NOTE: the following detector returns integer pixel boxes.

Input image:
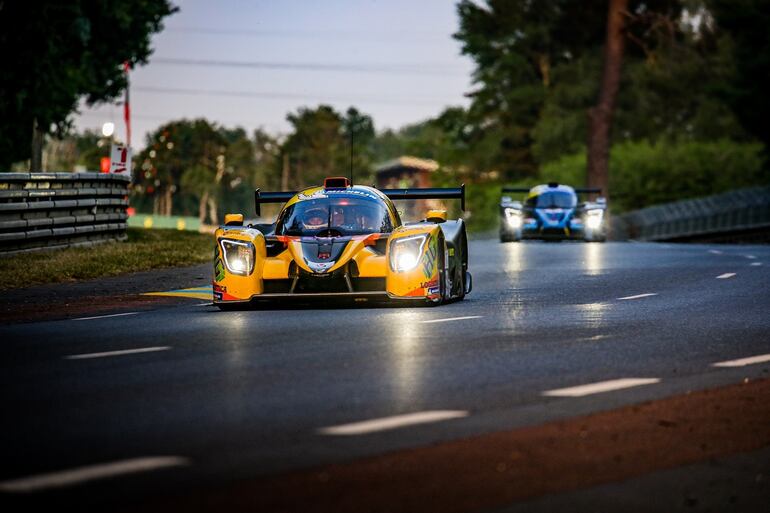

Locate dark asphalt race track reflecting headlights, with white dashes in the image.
[0,240,770,511]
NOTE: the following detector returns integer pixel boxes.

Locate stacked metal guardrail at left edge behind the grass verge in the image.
[0,173,130,255]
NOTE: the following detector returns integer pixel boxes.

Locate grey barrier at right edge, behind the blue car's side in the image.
[612,187,770,242]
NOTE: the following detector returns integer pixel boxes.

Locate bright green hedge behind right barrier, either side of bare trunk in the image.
[540,139,770,212]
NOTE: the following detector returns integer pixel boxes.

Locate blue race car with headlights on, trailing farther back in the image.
[500,182,607,242]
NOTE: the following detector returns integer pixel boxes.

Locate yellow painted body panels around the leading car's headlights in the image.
[213,187,444,303]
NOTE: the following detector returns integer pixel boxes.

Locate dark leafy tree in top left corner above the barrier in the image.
[0,0,177,170]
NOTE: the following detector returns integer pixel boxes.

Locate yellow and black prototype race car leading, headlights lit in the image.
[213,177,472,309]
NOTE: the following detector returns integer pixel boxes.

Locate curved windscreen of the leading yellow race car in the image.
[276,196,393,237]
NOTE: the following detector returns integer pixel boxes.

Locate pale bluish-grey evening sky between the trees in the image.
[75,0,473,149]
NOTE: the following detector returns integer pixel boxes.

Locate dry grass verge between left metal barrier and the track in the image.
[0,228,214,289]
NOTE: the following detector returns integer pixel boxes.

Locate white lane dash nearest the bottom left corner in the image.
[0,456,190,493]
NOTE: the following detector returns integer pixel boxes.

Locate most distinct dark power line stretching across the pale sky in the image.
[151,57,466,76]
